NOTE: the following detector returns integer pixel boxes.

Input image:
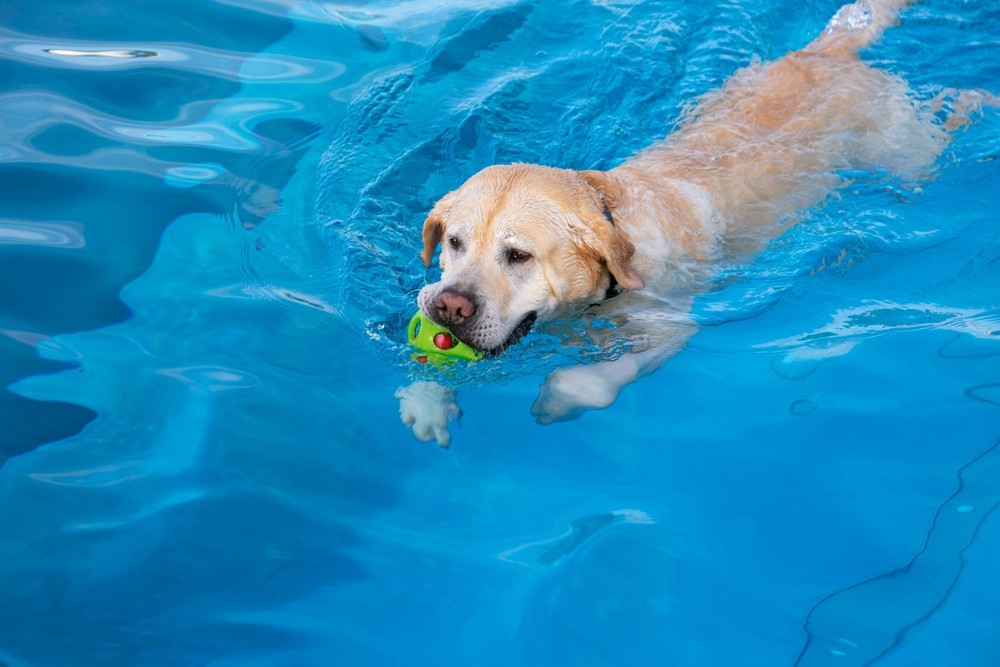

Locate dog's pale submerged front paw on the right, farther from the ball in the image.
[531,364,621,424]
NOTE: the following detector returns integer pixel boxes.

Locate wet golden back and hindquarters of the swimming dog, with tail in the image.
[616,0,947,247]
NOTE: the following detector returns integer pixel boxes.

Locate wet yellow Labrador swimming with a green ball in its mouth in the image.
[396,0,984,446]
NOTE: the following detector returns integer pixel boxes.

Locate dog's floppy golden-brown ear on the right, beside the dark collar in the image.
[578,171,645,289]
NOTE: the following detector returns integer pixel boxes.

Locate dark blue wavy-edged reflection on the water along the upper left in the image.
[0,0,292,461]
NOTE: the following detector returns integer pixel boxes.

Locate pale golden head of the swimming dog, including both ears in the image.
[418,164,643,352]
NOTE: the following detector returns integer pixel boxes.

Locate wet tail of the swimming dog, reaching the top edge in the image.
[803,0,915,58]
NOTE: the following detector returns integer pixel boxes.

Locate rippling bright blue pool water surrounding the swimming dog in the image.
[0,0,1000,667]
